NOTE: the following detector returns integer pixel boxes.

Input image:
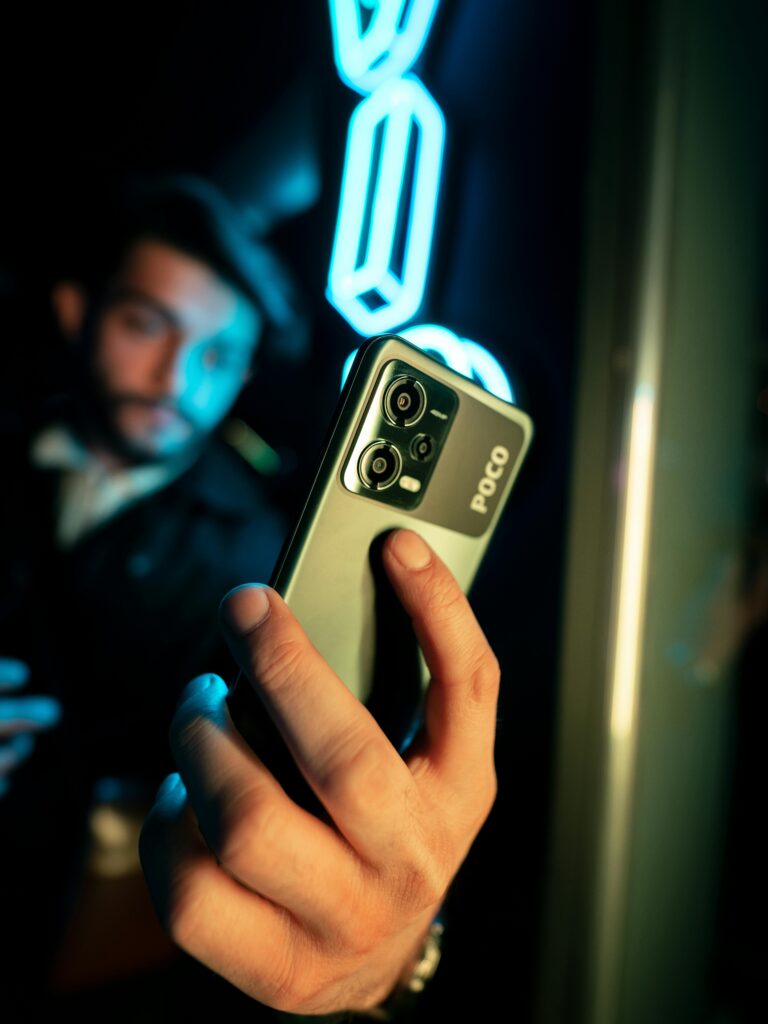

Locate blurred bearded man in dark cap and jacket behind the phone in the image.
[0,179,283,1001]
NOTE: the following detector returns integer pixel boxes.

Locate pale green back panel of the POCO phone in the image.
[272,336,532,700]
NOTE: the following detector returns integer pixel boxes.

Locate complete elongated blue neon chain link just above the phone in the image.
[327,76,445,335]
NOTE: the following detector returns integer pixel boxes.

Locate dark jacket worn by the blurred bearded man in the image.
[0,421,284,1007]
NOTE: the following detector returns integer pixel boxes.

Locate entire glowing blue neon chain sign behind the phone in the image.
[327,0,514,401]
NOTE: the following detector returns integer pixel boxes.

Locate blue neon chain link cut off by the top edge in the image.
[330,0,438,93]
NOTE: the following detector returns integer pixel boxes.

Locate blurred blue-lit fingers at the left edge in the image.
[0,657,61,798]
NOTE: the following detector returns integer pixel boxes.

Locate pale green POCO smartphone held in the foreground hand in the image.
[225,335,532,790]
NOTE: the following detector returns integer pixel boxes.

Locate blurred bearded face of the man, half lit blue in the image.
[92,238,261,460]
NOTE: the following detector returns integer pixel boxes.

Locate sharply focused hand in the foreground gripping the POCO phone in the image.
[140,530,499,1014]
